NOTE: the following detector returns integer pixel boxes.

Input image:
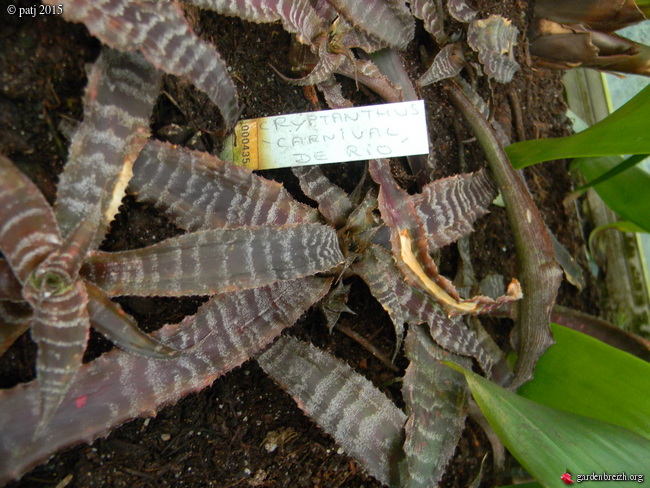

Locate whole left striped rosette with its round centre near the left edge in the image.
[0,43,343,444]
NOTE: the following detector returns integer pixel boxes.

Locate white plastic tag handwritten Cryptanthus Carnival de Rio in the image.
[221,100,429,170]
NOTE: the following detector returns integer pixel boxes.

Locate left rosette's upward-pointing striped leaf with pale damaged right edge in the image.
[56,48,161,243]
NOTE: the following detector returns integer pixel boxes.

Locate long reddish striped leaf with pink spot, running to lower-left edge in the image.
[0,277,331,484]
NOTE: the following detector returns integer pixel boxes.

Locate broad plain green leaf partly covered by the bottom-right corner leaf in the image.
[517,324,650,439]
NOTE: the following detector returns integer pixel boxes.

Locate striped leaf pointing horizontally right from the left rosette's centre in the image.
[83,224,344,296]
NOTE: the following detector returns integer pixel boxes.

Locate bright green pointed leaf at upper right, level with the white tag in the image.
[506,86,650,169]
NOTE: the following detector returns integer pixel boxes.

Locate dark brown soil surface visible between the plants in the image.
[0,0,599,488]
